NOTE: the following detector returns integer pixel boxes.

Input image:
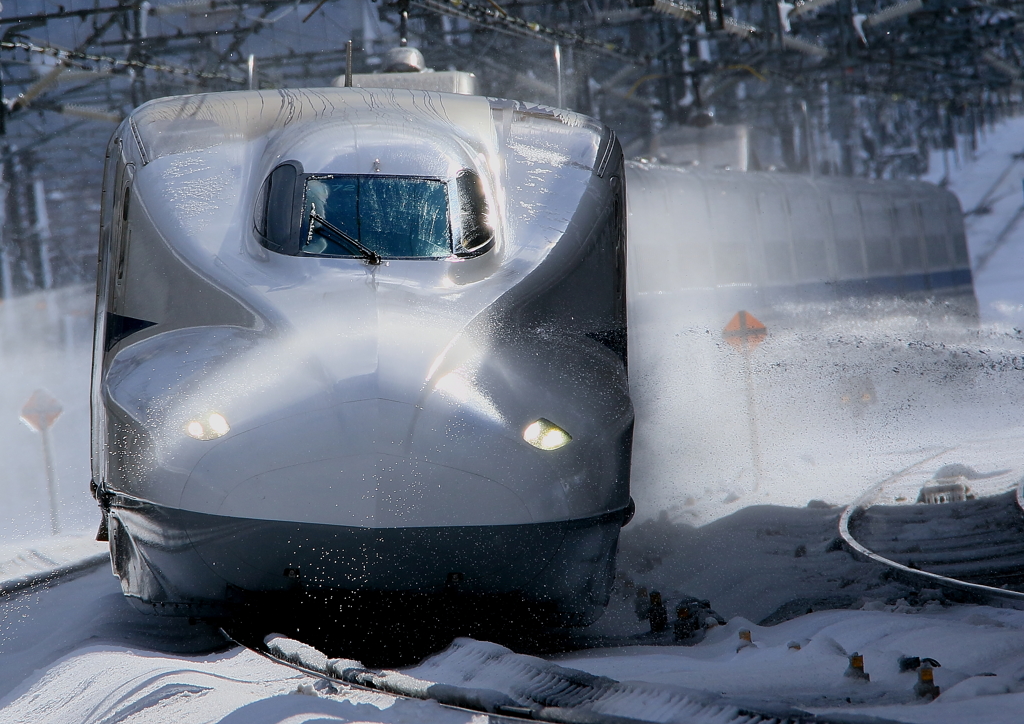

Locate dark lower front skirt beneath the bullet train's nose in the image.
[110,497,625,623]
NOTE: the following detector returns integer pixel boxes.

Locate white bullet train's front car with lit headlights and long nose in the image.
[92,88,633,625]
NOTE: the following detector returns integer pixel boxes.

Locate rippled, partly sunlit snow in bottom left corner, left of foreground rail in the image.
[0,565,458,724]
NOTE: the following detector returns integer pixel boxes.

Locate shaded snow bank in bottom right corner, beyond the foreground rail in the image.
[556,603,1024,724]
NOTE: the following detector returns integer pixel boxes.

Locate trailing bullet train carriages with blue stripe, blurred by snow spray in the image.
[626,162,978,329]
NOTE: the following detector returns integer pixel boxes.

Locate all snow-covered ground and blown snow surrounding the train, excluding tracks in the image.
[6,119,1024,724]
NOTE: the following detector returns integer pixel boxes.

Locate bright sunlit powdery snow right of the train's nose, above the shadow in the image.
[630,301,1024,525]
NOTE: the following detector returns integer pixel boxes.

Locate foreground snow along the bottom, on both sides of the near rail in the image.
[8,565,1024,724]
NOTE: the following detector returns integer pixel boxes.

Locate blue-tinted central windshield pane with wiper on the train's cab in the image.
[299,175,452,261]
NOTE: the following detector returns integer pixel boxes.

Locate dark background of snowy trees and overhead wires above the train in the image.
[0,0,1024,297]
